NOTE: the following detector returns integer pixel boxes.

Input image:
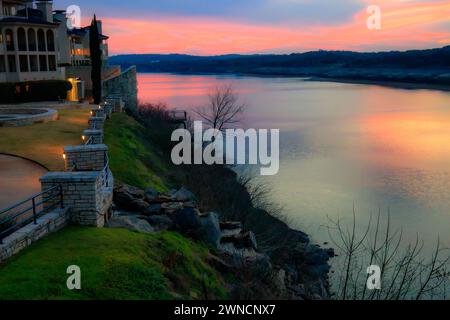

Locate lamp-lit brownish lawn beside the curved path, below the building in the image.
[0,109,90,171]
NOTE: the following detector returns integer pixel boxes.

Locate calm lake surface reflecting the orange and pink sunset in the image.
[139,74,450,250]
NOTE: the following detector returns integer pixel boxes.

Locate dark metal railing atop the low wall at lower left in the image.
[0,185,64,244]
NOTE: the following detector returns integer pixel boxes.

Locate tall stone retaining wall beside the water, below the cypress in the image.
[103,66,138,112]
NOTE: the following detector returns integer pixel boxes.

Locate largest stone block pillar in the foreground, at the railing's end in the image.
[40,171,113,227]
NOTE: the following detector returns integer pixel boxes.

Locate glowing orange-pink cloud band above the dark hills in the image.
[103,1,450,55]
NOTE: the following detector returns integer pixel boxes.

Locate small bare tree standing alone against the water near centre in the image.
[195,85,245,131]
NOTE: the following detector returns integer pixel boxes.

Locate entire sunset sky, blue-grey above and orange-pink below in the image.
[54,0,450,55]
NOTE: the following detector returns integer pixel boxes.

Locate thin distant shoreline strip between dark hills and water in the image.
[138,71,450,92]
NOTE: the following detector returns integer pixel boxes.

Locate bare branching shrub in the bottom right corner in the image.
[328,212,450,300]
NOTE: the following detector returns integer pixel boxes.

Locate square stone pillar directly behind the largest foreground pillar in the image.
[64,144,108,171]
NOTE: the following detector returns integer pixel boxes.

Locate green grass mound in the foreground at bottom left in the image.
[0,227,226,300]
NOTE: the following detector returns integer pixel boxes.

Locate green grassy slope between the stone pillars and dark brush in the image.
[105,113,168,191]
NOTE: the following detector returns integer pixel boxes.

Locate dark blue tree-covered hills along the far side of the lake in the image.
[110,46,450,85]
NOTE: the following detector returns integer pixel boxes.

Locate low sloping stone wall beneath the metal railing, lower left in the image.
[0,207,70,263]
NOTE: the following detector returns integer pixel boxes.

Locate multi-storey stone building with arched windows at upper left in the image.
[0,0,115,99]
